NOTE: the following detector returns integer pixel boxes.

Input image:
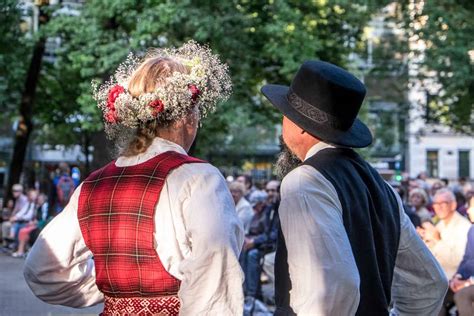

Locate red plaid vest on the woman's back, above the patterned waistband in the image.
[78,151,203,298]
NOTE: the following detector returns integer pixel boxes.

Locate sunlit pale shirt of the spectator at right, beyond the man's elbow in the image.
[428,211,471,279]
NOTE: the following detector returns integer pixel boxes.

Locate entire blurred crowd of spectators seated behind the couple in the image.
[0,164,474,316]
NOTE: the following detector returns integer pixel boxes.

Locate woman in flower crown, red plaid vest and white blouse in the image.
[24,42,243,315]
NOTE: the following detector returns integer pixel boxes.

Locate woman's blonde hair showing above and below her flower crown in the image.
[121,57,189,156]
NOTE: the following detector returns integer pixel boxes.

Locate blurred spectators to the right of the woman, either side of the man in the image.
[229,174,474,316]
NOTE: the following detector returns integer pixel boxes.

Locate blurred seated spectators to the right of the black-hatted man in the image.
[394,174,474,316]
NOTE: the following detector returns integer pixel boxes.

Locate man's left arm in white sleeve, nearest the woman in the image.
[279,166,360,315]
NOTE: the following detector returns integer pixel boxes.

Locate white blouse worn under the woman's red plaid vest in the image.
[24,138,244,316]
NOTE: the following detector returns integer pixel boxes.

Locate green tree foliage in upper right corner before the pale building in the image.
[404,0,474,135]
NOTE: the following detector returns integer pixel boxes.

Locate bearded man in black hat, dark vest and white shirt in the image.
[262,61,447,316]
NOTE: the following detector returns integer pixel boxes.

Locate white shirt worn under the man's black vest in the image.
[279,142,447,316]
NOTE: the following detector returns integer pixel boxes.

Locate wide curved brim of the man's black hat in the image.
[261,84,372,148]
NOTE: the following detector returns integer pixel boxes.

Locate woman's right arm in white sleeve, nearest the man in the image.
[179,169,244,316]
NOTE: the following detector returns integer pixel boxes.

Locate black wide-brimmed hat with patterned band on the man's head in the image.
[261,60,372,148]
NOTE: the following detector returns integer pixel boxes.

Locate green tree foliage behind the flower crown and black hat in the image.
[21,0,386,164]
